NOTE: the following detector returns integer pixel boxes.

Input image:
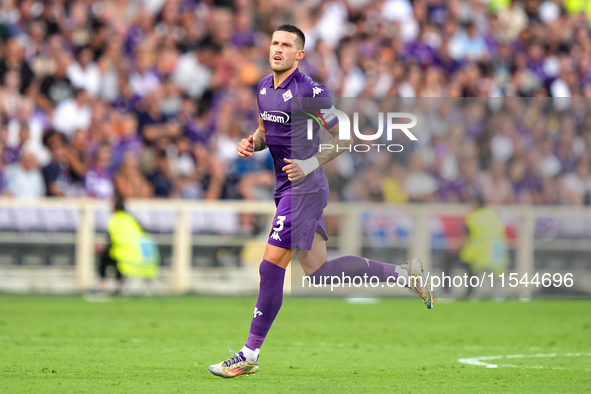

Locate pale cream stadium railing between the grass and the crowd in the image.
[0,198,591,297]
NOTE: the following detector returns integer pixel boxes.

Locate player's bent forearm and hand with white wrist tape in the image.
[283,123,352,182]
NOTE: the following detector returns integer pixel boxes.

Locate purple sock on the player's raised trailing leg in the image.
[310,256,398,282]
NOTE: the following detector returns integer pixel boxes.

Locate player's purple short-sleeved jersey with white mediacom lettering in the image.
[257,68,338,198]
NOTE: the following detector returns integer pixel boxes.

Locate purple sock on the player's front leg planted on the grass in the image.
[246,260,285,350]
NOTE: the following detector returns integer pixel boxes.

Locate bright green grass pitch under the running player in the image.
[0,295,591,393]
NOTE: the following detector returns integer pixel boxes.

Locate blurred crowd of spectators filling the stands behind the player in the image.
[0,0,591,205]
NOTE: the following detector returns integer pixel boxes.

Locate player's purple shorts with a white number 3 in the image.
[269,189,328,250]
